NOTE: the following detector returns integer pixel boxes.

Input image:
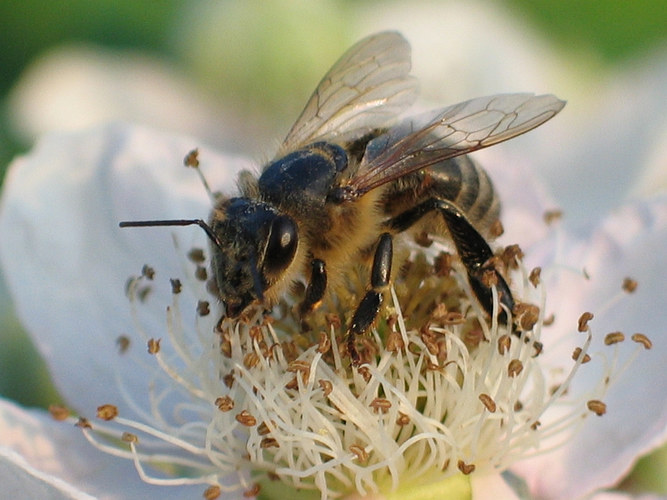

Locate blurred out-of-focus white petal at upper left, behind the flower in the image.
[9,45,235,148]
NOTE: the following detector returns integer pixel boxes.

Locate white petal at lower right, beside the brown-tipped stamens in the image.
[516,196,667,499]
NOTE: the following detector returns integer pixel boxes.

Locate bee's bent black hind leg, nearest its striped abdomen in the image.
[387,198,514,323]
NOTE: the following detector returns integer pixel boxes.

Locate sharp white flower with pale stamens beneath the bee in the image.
[0,111,667,498]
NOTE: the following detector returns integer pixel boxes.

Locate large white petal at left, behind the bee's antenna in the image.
[0,126,253,416]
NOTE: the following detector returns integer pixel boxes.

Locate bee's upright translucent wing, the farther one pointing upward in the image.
[279,31,417,154]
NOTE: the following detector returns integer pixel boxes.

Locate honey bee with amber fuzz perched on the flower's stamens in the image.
[120,32,565,365]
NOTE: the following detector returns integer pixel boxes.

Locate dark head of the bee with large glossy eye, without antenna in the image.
[209,198,298,317]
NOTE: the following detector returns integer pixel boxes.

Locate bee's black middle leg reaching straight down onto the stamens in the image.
[347,233,394,366]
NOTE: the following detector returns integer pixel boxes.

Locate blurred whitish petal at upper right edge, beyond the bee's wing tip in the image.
[528,52,667,228]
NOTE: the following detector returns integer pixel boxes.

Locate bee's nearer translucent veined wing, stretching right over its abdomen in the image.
[346,94,565,197]
